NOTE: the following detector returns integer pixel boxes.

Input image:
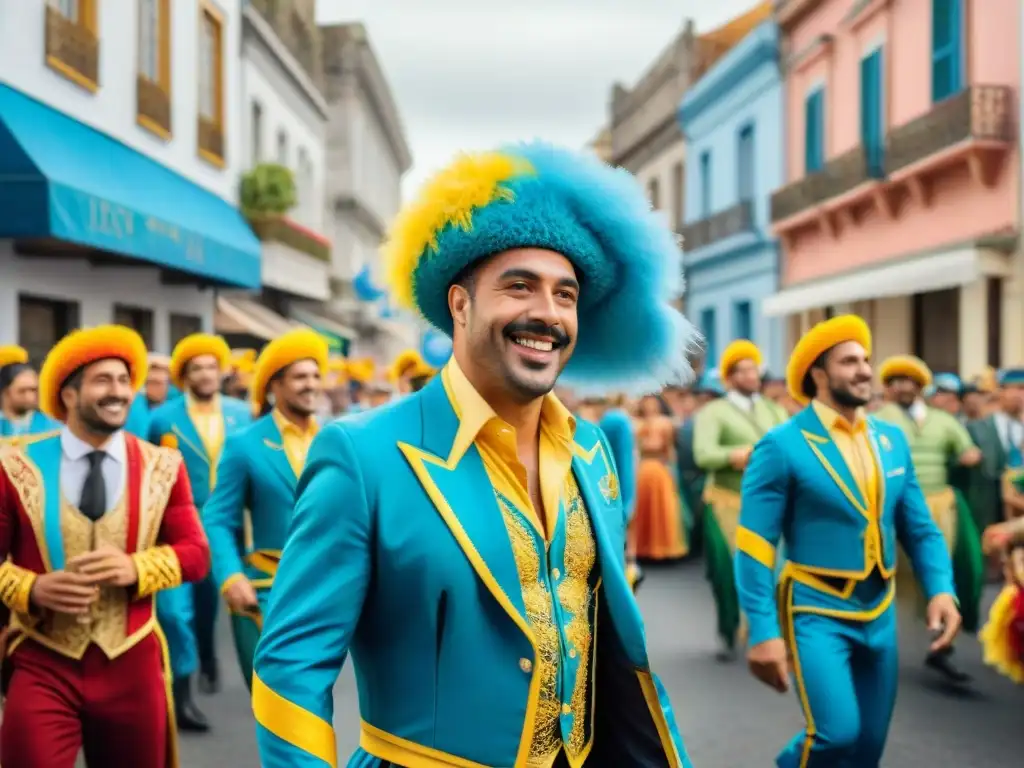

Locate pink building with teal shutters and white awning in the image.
[765,0,1024,376]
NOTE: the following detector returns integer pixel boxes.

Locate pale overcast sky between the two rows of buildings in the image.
[317,0,756,194]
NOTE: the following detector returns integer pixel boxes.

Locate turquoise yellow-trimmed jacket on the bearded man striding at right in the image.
[735,408,955,644]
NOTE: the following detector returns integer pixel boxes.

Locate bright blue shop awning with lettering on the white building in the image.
[0,85,260,289]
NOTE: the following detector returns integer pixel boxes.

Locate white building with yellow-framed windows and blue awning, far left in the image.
[0,0,260,358]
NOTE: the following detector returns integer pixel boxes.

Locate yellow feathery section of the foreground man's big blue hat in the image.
[381,153,534,309]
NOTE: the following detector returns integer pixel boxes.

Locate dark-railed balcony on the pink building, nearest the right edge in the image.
[885,85,1016,198]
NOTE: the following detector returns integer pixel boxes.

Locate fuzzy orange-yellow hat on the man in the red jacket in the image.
[39,326,150,421]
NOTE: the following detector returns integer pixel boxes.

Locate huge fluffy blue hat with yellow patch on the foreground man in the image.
[383,142,698,394]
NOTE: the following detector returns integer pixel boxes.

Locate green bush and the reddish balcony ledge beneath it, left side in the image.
[239,163,331,261]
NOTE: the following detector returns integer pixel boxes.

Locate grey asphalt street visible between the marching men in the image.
[181,563,1024,768]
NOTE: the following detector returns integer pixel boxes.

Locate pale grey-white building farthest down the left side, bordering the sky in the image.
[321,24,420,361]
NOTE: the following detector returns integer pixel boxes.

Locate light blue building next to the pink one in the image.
[679,20,785,374]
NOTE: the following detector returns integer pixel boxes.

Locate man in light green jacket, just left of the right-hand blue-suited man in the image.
[693,339,786,662]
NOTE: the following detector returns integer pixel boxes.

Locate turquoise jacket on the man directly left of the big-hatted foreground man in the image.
[203,414,298,609]
